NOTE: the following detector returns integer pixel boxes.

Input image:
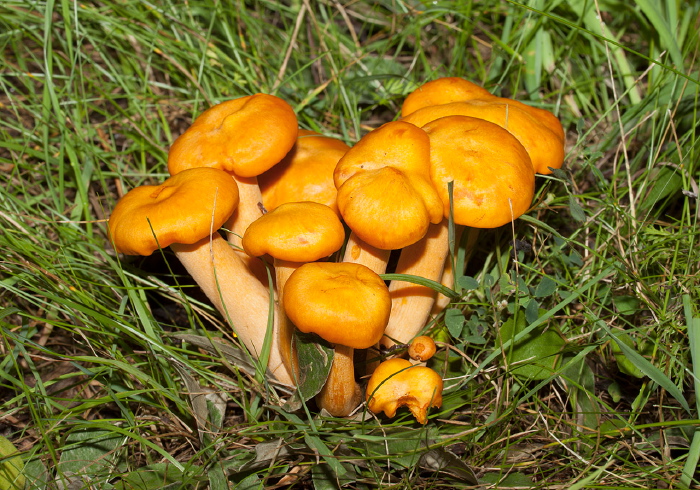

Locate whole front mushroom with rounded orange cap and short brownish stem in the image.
[284,262,391,417]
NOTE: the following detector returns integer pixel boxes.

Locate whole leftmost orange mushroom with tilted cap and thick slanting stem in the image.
[109,168,291,384]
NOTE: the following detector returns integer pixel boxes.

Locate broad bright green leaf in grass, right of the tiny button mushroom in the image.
[500,310,566,380]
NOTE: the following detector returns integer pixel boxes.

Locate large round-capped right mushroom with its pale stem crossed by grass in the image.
[381,116,535,347]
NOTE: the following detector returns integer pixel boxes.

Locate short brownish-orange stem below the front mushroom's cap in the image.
[316,344,362,417]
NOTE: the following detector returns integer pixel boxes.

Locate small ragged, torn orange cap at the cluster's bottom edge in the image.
[367,357,443,424]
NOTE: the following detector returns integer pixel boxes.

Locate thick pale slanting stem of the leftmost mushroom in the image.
[170,233,294,385]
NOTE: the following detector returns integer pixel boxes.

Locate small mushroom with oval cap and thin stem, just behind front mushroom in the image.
[242,201,345,376]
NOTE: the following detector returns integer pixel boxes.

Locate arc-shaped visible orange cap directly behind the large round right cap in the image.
[403,96,564,174]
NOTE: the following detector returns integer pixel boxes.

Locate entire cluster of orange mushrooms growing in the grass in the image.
[109,77,564,423]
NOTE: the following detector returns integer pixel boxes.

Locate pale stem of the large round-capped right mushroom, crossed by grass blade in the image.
[381,220,449,347]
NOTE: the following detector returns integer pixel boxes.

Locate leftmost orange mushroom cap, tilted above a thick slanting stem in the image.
[109,168,238,255]
